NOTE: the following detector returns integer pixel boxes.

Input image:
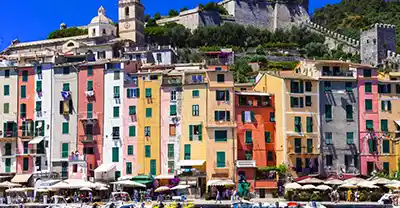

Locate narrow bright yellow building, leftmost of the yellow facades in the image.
[136,72,162,175]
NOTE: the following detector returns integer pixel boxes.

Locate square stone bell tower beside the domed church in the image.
[118,0,144,45]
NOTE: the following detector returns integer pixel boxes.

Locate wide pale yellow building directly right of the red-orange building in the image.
[254,72,320,176]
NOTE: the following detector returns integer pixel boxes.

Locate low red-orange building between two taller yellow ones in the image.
[235,91,277,197]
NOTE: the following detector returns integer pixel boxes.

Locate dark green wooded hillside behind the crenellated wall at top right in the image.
[312,0,400,49]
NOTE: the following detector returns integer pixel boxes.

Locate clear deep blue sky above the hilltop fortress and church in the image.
[0,0,340,50]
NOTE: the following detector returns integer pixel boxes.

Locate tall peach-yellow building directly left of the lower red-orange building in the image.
[206,70,237,183]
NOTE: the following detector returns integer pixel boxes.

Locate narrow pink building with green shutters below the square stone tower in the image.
[357,67,381,175]
